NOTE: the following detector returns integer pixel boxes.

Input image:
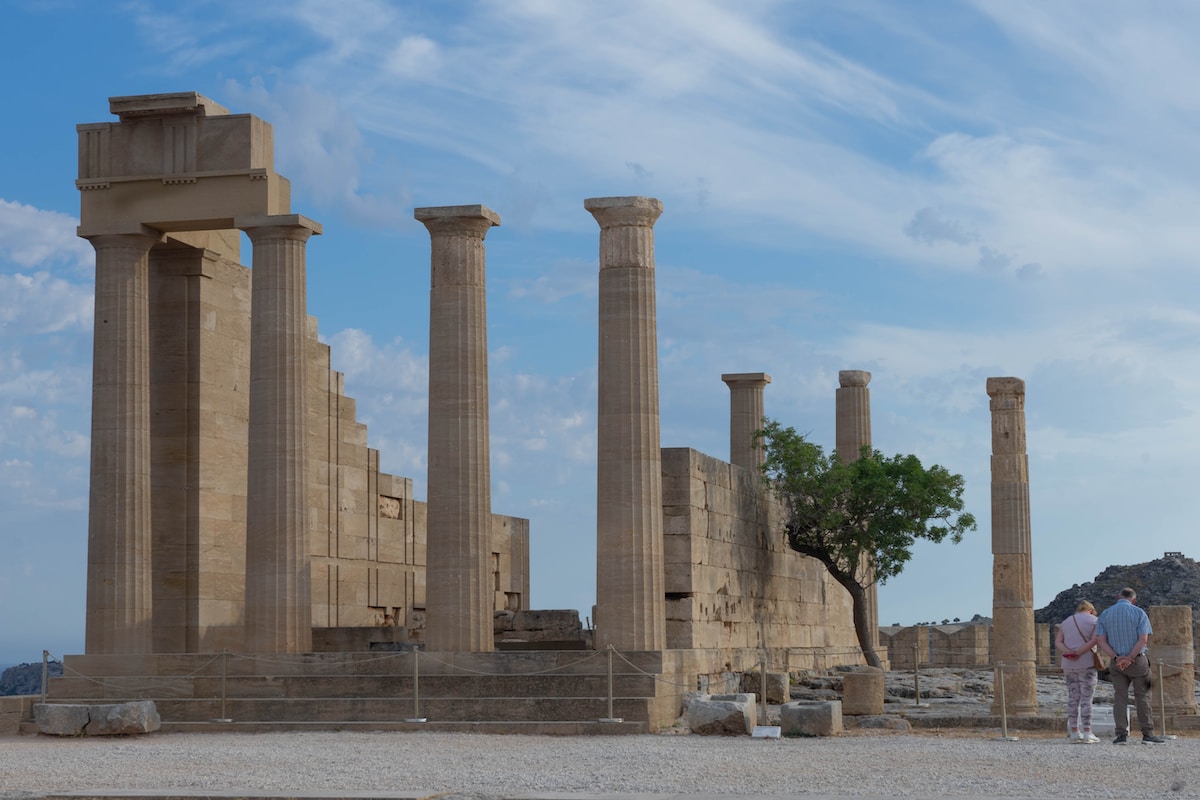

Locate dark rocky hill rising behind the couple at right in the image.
[1033,553,1200,624]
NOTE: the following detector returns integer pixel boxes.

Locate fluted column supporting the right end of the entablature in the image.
[236,215,320,652]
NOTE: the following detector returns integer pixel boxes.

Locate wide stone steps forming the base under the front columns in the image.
[23,650,682,734]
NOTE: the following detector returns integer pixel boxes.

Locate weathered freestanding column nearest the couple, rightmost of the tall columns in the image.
[988,378,1038,716]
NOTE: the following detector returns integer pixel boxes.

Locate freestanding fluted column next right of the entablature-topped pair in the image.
[414,205,500,652]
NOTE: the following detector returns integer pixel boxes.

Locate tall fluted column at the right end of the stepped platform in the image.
[583,197,666,650]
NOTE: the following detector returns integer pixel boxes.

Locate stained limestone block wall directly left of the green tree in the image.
[662,447,863,669]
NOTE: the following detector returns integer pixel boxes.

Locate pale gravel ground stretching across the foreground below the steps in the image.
[0,732,1200,800]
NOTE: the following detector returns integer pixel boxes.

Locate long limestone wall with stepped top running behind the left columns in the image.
[149,235,529,652]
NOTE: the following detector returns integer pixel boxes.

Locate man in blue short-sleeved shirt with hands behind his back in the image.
[1096,587,1166,745]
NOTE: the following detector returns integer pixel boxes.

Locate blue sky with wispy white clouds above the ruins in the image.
[0,0,1200,663]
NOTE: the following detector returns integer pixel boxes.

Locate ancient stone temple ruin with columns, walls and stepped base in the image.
[46,92,870,729]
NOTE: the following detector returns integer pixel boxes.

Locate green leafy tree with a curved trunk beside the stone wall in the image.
[756,420,976,667]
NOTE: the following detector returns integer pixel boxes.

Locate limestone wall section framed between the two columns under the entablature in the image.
[150,240,250,652]
